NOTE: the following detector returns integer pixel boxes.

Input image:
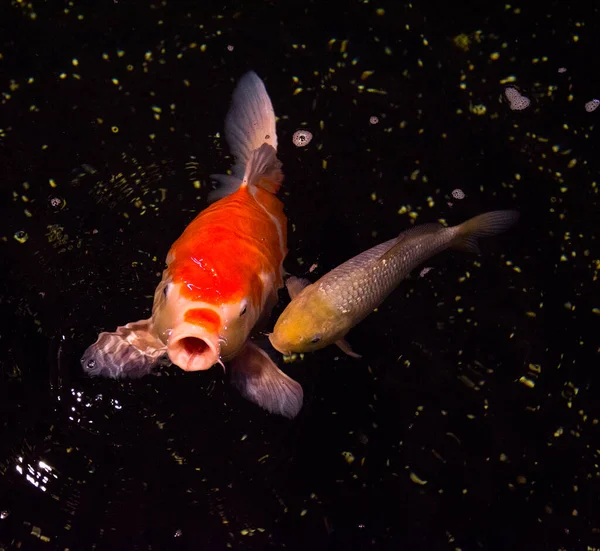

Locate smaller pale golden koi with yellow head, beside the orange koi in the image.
[269,211,519,357]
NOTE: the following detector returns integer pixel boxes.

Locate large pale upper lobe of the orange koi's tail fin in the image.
[209,71,277,200]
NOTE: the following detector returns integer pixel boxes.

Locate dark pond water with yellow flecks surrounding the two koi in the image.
[0,0,600,550]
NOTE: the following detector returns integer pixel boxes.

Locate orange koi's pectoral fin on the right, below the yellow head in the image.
[229,341,304,419]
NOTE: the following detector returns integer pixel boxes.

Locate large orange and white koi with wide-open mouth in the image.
[81,72,303,418]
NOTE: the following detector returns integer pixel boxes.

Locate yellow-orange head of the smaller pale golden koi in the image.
[269,289,343,354]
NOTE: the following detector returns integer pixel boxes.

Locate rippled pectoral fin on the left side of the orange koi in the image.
[81,318,166,379]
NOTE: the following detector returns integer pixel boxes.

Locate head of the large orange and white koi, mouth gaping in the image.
[152,269,261,371]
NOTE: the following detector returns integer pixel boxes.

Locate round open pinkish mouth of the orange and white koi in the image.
[167,324,220,371]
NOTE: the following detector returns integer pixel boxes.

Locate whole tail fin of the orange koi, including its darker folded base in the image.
[209,71,283,201]
